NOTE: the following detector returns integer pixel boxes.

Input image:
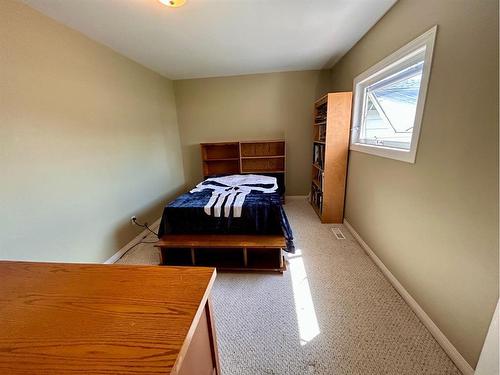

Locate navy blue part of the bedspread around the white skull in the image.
[158,190,295,253]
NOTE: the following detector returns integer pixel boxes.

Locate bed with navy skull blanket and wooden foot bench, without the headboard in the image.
[158,174,294,271]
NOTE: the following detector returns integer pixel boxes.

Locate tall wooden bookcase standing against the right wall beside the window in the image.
[310,92,352,223]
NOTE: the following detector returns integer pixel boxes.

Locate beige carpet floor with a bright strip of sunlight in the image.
[120,198,460,375]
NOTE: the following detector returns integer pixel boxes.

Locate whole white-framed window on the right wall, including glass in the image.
[350,26,437,163]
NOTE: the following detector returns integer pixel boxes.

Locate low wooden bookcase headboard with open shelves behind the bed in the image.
[201,140,286,178]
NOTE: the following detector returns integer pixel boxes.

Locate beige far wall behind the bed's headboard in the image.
[174,71,328,195]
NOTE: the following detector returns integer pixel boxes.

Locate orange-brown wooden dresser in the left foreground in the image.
[0,262,220,375]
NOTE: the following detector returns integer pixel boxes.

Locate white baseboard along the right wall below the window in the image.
[344,220,474,375]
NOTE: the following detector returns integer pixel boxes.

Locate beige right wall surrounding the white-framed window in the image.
[333,0,498,366]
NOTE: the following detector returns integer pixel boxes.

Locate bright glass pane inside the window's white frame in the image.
[359,59,424,150]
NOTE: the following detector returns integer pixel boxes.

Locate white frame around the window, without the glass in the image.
[350,25,437,163]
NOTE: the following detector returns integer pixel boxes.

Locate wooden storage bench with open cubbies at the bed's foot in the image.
[155,234,286,272]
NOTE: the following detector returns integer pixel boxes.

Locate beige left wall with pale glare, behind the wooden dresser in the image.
[0,0,184,262]
